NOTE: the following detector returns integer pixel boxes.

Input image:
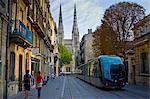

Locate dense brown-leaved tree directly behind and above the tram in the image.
[94,21,118,56]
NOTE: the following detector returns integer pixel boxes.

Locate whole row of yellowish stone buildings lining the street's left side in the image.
[0,0,59,99]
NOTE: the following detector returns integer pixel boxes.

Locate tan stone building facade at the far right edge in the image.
[133,15,150,85]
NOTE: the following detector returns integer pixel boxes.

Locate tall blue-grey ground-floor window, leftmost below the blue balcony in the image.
[9,52,15,81]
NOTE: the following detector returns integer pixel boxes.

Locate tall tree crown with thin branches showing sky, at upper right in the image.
[103,2,145,52]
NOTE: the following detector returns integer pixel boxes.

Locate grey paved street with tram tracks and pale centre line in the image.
[9,76,150,99]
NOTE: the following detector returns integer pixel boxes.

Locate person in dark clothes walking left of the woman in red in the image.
[23,70,31,99]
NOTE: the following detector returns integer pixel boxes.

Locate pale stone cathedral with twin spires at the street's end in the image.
[58,5,79,72]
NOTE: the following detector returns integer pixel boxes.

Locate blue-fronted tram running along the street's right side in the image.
[76,55,127,88]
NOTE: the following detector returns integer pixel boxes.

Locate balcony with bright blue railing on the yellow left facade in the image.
[11,20,32,44]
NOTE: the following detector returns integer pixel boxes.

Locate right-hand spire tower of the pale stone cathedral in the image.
[72,5,79,57]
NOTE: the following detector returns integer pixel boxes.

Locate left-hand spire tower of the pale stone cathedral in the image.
[58,4,64,44]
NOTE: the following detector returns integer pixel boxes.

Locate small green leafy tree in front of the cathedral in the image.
[58,45,72,67]
